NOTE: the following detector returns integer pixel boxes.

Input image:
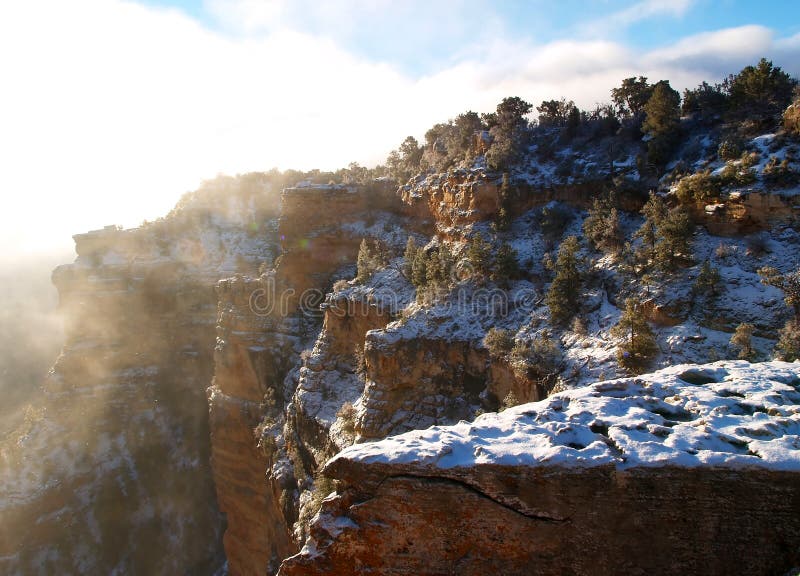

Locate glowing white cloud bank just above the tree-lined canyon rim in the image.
[0,0,800,260]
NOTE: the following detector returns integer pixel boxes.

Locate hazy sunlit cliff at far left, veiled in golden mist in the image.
[0,183,275,574]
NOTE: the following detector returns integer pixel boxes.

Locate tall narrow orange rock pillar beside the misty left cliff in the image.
[208,277,297,574]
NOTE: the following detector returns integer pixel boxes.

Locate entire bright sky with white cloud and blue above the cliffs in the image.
[0,0,800,263]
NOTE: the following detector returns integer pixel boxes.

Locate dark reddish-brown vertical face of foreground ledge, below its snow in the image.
[279,460,800,576]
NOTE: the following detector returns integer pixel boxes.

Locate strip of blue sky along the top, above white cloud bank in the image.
[134,0,800,75]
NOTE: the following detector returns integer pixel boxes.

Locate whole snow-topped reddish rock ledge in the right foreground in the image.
[279,362,800,576]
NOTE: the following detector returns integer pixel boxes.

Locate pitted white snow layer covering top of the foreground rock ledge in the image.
[328,361,800,471]
